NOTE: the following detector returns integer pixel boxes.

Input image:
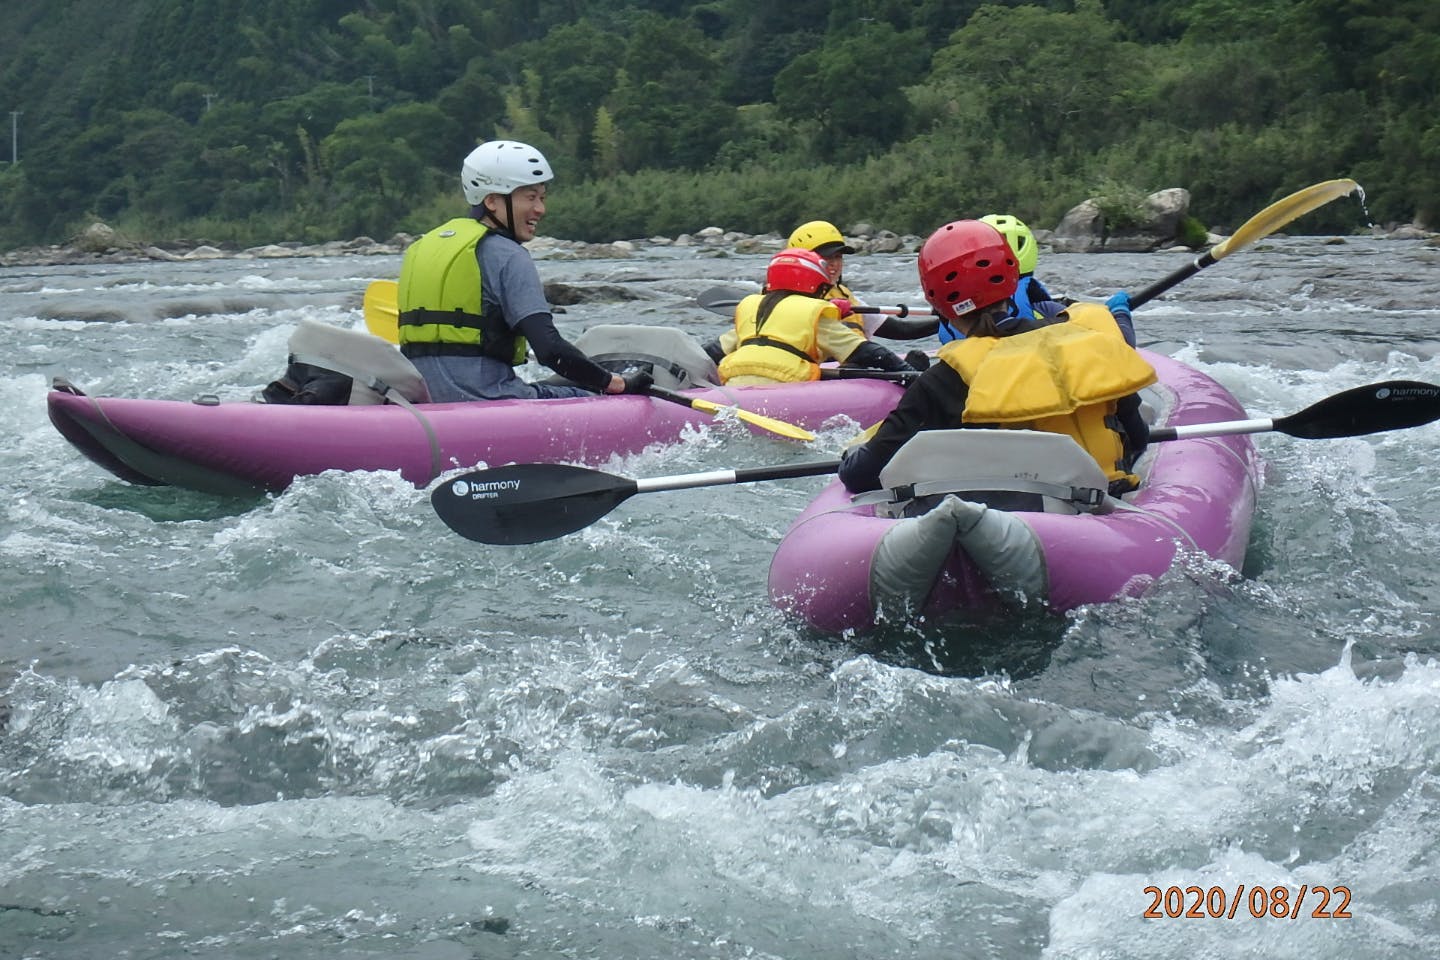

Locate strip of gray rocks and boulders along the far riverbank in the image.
[0,187,1440,266]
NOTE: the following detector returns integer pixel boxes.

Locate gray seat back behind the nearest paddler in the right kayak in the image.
[855,429,1113,517]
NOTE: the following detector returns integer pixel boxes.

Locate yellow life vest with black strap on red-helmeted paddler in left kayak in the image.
[720,291,840,383]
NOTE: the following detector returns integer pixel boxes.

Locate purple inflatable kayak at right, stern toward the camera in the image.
[769,353,1260,632]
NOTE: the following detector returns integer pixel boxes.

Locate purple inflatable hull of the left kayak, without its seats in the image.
[48,379,903,495]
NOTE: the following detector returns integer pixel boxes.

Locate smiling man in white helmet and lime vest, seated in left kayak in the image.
[399,140,651,403]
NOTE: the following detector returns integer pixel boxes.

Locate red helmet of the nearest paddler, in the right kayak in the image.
[919,220,1020,320]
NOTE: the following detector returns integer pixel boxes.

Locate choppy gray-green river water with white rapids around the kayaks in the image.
[0,237,1440,960]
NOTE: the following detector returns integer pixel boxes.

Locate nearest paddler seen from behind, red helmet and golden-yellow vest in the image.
[840,220,1156,495]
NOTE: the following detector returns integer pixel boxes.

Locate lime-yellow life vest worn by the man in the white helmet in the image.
[396,217,526,366]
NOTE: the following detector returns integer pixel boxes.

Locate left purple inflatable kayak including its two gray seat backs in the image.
[49,320,904,497]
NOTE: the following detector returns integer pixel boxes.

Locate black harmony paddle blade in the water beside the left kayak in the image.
[431,463,636,544]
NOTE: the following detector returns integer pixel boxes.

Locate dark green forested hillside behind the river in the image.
[0,0,1440,248]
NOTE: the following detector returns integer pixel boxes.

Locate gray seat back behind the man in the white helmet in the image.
[289,320,431,406]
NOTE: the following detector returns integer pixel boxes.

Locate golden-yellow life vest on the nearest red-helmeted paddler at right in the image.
[939,304,1156,485]
